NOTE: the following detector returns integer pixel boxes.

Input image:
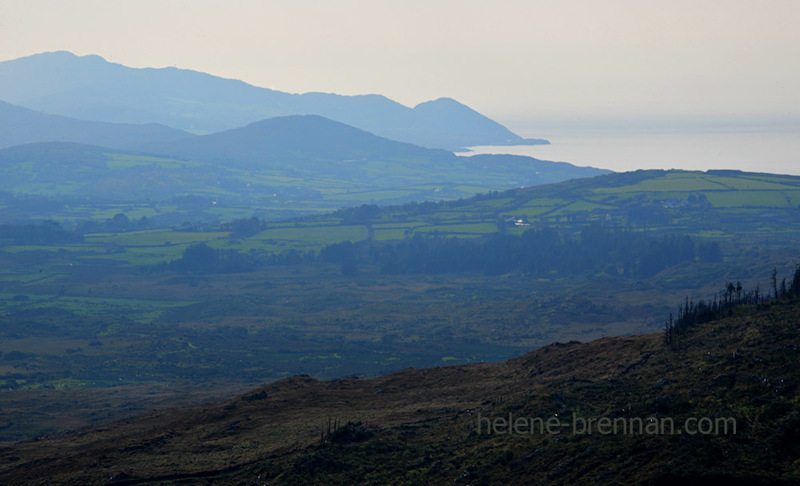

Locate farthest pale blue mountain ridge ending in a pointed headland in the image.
[0,52,547,150]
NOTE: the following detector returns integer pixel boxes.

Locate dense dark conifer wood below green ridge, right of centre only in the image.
[319,225,722,278]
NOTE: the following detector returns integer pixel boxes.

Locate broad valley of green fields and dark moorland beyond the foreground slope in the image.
[0,171,800,439]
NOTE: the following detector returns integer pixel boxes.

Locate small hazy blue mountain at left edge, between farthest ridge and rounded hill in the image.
[0,101,192,149]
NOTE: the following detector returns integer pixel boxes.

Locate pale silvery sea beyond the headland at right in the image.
[461,122,800,175]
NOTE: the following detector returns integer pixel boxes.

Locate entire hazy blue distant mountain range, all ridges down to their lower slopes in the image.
[0,52,608,221]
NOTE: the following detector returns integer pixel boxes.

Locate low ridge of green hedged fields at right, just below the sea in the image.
[358,167,800,241]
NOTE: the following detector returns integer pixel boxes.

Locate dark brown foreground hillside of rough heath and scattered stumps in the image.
[0,292,800,485]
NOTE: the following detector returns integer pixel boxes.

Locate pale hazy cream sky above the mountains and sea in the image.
[0,0,800,123]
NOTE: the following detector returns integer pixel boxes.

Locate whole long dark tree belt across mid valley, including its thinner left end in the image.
[151,219,722,278]
